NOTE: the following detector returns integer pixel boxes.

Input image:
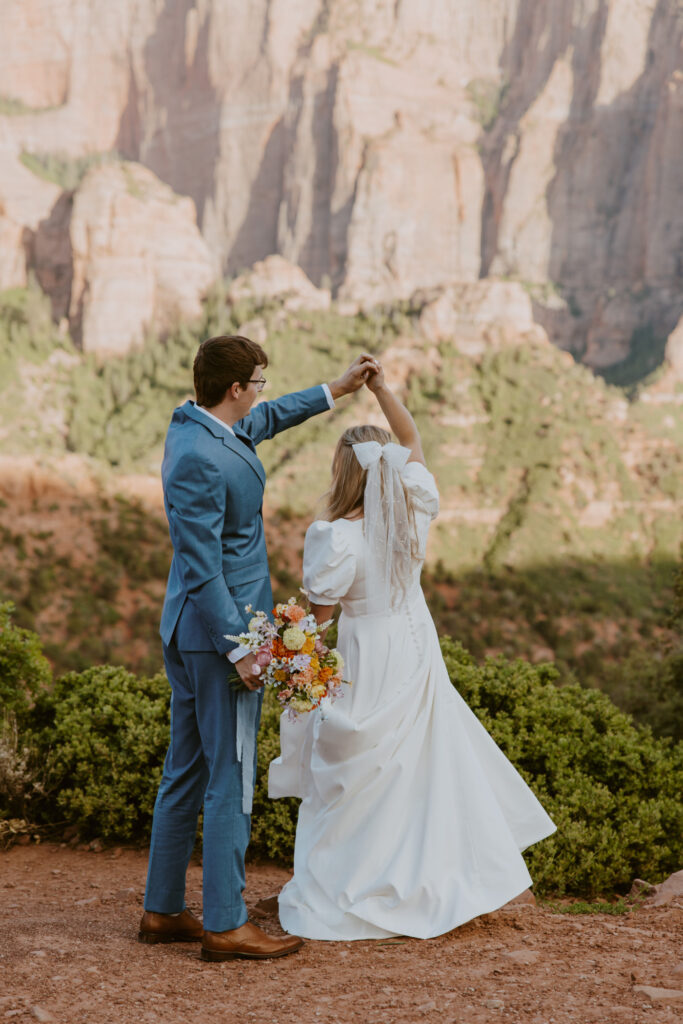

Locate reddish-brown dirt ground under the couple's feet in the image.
[0,844,683,1024]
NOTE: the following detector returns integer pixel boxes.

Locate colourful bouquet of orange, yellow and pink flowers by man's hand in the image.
[226,597,348,717]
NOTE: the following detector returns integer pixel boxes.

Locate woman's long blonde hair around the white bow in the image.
[323,424,419,557]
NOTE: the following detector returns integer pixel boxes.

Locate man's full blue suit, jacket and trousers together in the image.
[144,387,330,932]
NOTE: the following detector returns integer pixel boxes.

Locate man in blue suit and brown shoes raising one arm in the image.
[138,336,377,961]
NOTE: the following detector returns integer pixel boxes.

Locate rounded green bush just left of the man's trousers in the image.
[32,666,169,840]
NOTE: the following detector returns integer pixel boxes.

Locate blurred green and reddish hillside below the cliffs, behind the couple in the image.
[0,276,683,731]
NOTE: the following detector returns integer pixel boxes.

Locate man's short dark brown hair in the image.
[193,334,268,409]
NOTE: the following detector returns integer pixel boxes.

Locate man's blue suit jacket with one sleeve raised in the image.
[160,386,330,654]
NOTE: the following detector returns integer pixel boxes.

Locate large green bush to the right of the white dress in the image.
[441,639,683,895]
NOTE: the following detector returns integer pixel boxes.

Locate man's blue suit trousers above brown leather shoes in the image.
[144,643,262,932]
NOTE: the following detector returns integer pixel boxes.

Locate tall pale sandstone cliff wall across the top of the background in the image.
[0,0,683,367]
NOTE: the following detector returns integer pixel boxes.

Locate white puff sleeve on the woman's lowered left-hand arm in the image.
[303,519,355,604]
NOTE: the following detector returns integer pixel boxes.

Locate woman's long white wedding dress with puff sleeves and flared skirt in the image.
[269,462,555,940]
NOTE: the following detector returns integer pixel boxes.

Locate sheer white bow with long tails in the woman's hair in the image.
[352,441,413,613]
